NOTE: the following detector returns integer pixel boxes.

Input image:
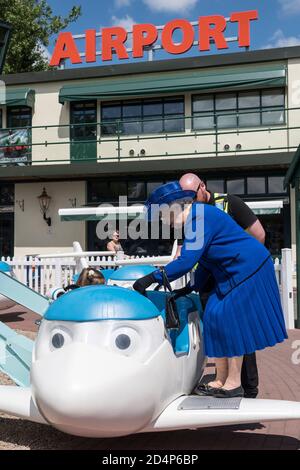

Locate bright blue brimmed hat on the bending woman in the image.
[145,181,196,220]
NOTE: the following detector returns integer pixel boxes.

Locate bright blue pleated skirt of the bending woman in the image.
[203,258,287,357]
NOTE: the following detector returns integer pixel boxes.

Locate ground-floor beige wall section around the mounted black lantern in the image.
[15,181,86,256]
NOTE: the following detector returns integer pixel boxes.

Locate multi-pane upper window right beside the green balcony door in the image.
[101,97,185,135]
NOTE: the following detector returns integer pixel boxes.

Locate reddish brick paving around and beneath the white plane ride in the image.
[0,308,300,451]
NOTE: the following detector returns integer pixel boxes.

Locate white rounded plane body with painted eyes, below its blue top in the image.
[31,312,204,437]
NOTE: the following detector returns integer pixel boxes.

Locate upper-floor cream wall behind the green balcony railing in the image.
[4,59,300,164]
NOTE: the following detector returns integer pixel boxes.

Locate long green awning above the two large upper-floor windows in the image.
[59,64,286,104]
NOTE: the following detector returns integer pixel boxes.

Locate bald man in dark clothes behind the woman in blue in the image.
[179,173,265,398]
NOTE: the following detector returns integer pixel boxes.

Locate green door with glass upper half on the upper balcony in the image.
[71,101,97,162]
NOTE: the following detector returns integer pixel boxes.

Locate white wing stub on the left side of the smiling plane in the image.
[0,385,48,424]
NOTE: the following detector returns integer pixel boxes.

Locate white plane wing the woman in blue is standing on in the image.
[141,395,300,432]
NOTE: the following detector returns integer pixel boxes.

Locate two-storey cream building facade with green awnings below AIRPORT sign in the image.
[0,47,300,256]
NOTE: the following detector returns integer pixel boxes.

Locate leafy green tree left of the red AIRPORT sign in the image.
[0,0,81,73]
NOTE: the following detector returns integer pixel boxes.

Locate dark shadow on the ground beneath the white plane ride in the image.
[0,418,300,451]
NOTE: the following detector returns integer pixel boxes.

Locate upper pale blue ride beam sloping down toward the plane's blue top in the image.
[0,272,49,316]
